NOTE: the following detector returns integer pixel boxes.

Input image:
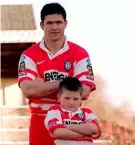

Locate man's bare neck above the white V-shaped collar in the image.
[44,37,65,54]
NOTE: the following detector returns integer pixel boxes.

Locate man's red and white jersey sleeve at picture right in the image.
[74,48,96,91]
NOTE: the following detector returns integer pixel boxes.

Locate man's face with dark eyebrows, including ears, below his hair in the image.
[40,14,67,41]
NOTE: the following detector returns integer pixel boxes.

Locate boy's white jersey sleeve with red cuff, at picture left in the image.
[44,107,65,133]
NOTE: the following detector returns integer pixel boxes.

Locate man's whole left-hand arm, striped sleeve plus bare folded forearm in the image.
[18,52,59,99]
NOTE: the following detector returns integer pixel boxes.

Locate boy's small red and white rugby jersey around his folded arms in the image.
[44,105,101,145]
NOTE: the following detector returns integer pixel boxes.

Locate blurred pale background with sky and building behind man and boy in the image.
[0,0,135,145]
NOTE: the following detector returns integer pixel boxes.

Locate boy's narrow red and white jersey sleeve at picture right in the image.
[85,109,101,139]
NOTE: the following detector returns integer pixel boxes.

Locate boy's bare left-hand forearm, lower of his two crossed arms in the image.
[51,128,84,139]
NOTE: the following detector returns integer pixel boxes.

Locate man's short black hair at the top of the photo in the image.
[40,3,66,22]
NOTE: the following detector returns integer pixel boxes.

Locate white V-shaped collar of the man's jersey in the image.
[40,36,69,59]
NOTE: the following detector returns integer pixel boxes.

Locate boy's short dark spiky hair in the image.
[59,77,82,95]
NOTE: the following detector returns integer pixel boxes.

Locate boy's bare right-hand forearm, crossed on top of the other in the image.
[66,123,98,136]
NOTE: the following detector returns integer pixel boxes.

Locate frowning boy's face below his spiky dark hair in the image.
[58,89,82,111]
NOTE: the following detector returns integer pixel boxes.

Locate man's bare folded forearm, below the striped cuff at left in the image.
[20,80,59,99]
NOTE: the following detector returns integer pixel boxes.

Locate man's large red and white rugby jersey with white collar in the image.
[18,37,95,113]
